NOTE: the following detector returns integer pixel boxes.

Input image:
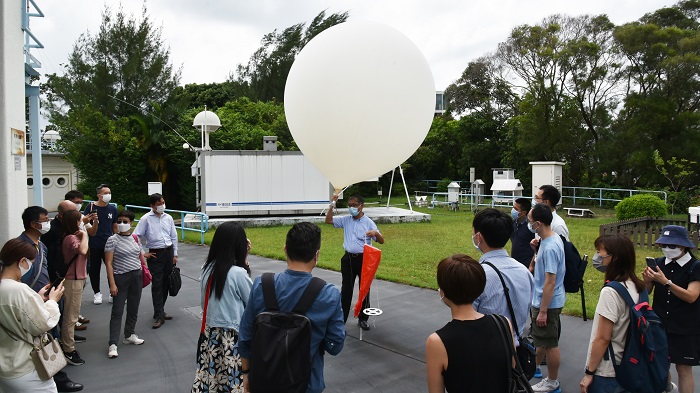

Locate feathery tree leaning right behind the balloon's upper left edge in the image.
[229,11,350,102]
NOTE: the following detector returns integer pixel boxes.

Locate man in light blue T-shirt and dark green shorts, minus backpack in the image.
[527,204,566,393]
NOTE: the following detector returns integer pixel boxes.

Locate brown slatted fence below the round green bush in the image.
[600,217,700,248]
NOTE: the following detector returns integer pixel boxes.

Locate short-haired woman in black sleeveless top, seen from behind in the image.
[425,254,515,393]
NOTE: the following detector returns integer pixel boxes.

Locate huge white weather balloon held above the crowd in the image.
[284,22,435,189]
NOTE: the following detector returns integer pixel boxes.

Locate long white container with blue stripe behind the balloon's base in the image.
[200,150,333,217]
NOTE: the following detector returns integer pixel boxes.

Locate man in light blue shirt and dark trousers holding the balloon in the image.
[325,194,384,330]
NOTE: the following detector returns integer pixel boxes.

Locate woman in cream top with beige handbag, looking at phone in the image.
[0,239,63,392]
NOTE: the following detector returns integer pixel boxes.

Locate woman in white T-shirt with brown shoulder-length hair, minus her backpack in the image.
[580,235,646,393]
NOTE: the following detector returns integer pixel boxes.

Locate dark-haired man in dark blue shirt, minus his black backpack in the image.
[238,222,345,393]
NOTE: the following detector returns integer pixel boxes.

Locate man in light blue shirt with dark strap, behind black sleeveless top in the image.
[472,209,534,345]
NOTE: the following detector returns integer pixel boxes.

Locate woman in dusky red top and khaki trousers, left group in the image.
[61,210,89,366]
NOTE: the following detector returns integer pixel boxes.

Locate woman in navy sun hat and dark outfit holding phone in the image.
[642,225,700,393]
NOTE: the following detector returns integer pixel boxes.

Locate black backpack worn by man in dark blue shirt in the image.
[248,273,326,393]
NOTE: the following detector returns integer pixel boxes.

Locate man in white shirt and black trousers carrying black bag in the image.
[133,194,177,329]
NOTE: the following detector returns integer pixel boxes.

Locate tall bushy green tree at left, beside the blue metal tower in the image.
[43,5,179,203]
